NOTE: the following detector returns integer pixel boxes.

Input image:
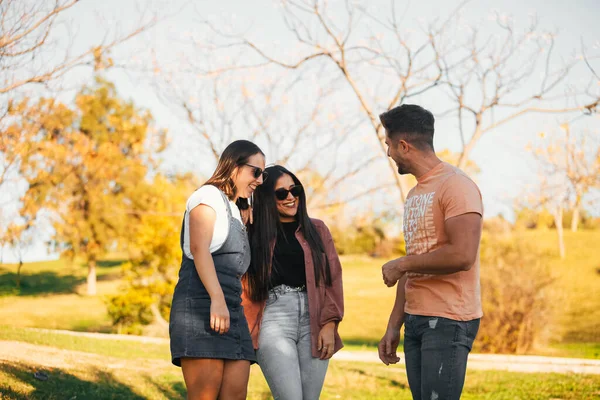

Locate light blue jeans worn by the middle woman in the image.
[256,285,329,400]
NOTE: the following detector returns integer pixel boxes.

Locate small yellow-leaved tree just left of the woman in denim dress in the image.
[108,173,198,334]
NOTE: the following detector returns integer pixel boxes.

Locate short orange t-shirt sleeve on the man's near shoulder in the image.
[440,174,483,221]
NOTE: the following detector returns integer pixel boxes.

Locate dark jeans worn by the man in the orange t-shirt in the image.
[404,314,480,400]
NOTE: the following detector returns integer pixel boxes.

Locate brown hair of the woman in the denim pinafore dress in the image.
[204,140,265,200]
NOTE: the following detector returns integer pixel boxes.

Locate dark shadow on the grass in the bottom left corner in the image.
[0,363,144,400]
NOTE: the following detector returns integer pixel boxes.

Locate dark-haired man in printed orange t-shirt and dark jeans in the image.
[379,104,483,400]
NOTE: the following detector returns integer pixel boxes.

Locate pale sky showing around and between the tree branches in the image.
[3,0,600,261]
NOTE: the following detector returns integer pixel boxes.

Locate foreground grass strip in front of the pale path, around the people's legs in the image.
[0,326,600,400]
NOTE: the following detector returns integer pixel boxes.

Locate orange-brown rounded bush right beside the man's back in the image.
[475,234,558,354]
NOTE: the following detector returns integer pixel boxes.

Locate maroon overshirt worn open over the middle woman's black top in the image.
[242,218,344,357]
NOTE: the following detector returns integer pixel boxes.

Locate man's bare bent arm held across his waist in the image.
[383,212,481,286]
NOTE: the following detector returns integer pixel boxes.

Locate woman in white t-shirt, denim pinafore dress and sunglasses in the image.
[169,140,267,399]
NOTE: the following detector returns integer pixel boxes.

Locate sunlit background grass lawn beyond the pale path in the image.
[0,231,600,358]
